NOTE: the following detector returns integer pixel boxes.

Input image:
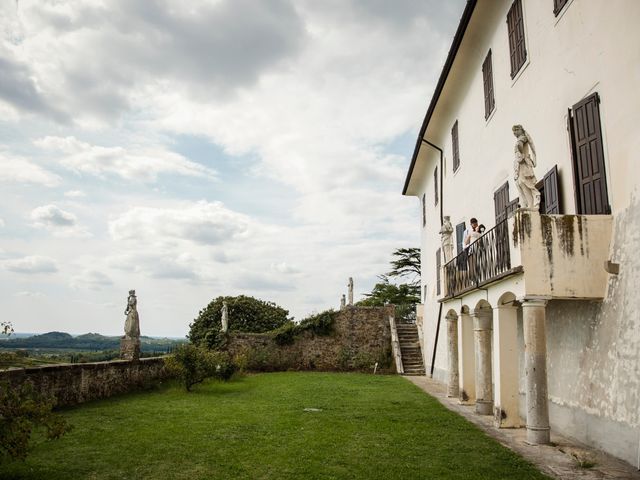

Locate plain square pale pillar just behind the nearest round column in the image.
[493,305,521,428]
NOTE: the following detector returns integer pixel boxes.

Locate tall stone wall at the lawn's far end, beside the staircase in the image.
[225,306,395,372]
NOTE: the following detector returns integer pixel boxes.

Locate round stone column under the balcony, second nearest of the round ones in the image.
[473,308,493,415]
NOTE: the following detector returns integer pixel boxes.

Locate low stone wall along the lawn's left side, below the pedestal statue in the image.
[0,358,167,407]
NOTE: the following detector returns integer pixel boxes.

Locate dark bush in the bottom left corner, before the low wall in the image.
[0,381,72,461]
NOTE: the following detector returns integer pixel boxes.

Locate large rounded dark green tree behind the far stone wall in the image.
[188,295,291,348]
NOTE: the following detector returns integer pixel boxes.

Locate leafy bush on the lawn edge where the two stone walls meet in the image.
[165,343,238,392]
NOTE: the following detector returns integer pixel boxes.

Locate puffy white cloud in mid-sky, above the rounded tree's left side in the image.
[109,201,249,245]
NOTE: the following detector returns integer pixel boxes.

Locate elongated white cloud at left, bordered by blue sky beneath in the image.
[35,136,215,182]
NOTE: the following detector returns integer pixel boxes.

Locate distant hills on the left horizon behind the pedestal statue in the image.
[0,332,186,352]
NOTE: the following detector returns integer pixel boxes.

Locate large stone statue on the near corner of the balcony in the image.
[512,125,540,210]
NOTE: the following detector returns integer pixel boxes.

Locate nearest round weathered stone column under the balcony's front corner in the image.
[522,298,550,445]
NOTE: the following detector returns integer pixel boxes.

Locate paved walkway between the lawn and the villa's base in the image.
[404,376,640,480]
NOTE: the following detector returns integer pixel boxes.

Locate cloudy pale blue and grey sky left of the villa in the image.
[0,0,464,336]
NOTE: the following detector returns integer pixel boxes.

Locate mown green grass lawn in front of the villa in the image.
[0,373,547,480]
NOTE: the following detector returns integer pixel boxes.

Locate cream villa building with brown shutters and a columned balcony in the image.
[403,0,640,464]
